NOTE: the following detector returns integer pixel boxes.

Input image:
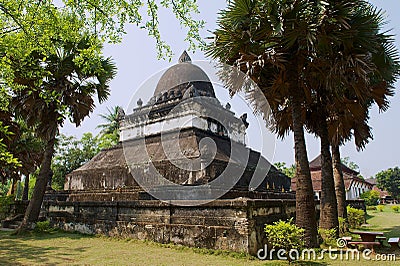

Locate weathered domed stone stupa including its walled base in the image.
[43,52,295,254]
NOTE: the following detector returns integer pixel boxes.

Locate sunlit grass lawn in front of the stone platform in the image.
[0,207,400,266]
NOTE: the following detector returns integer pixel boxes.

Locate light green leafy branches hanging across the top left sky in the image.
[0,0,204,58]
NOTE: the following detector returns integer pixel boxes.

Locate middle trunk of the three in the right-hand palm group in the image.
[319,117,339,234]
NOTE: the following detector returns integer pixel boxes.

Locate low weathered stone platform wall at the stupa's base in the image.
[42,195,295,255]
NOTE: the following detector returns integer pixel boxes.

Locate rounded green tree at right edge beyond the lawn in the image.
[375,167,400,198]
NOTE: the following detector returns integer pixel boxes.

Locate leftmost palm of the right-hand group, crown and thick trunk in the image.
[207,0,321,247]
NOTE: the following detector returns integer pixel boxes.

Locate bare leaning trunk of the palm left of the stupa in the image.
[18,133,56,232]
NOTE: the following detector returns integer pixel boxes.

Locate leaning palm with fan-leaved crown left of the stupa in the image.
[10,34,116,230]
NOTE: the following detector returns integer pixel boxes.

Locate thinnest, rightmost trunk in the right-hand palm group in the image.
[332,145,347,219]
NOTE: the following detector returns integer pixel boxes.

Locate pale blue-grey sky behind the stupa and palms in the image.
[61,0,400,177]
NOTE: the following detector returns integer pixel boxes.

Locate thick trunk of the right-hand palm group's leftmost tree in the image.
[292,92,318,247]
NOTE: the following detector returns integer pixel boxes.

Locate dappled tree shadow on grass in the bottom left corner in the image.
[0,232,90,265]
